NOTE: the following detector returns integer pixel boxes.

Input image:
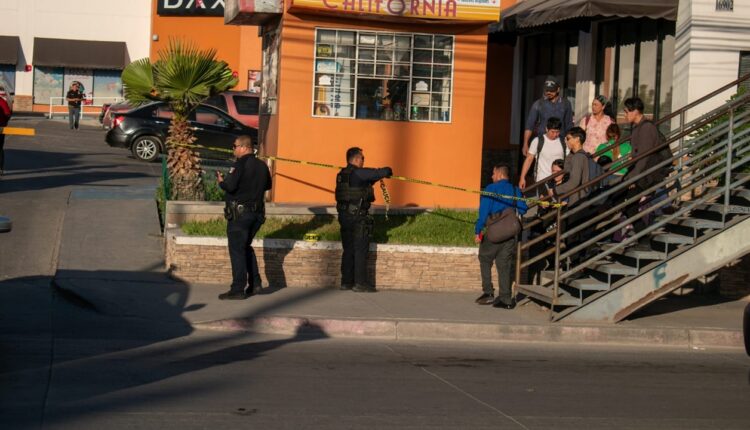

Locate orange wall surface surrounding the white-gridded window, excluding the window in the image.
[274,13,487,207]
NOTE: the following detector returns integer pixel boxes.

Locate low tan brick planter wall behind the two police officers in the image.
[166,229,490,292]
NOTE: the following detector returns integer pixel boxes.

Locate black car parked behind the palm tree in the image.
[105,103,258,161]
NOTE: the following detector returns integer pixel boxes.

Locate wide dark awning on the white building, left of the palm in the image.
[34,37,130,70]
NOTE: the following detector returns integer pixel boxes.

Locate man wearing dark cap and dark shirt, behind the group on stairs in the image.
[522,76,573,157]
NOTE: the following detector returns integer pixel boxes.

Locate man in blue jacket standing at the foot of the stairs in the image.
[474,164,528,309]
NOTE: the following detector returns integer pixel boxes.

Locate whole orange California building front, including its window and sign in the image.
[226,0,500,207]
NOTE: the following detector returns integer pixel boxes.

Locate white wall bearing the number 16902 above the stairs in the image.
[672,0,750,120]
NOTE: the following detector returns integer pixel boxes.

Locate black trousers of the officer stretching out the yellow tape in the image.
[339,214,372,286]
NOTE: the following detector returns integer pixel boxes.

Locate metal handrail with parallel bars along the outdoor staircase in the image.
[516,79,750,312]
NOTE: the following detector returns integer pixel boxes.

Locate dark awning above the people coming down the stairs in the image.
[490,0,679,33]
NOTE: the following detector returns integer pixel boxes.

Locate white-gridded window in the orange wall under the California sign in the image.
[313,29,454,122]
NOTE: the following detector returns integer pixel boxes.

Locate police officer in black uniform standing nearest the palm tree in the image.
[216,136,271,300]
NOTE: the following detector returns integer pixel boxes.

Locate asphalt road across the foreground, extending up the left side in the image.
[0,120,750,430]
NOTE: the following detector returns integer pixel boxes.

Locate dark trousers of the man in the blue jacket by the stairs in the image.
[479,237,516,303]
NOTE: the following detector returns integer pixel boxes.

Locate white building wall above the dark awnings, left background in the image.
[0,0,151,101]
